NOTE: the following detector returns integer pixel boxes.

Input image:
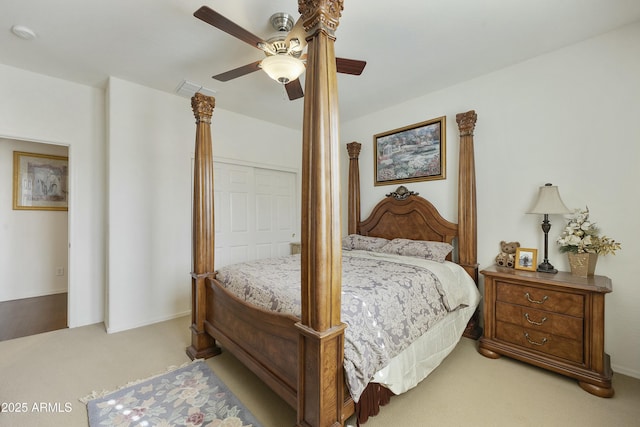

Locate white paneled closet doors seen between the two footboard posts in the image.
[214,162,297,268]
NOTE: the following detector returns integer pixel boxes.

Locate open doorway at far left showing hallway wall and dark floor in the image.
[0,138,69,340]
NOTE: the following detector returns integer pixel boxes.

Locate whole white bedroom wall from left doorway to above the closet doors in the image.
[0,65,301,331]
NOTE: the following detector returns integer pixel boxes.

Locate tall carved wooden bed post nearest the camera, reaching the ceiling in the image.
[296,0,345,427]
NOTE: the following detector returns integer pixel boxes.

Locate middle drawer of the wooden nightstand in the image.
[496,302,583,341]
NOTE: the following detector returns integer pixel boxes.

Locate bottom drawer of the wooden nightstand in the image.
[496,322,583,363]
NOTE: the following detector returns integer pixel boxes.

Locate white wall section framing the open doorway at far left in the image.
[0,65,105,327]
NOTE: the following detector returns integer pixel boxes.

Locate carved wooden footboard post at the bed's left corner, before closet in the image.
[187,93,220,359]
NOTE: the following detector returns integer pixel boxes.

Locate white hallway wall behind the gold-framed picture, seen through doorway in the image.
[0,138,69,301]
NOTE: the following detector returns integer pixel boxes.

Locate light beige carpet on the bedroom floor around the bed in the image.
[0,317,640,427]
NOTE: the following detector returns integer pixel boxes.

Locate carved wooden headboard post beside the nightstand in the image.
[456,110,482,339]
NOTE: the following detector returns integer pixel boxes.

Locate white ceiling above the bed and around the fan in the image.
[0,0,640,129]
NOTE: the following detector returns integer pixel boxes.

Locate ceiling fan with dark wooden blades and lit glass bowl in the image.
[193,6,367,101]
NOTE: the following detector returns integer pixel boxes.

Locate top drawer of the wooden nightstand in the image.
[496,281,584,317]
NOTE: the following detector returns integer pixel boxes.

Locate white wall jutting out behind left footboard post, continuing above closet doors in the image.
[106,78,301,332]
